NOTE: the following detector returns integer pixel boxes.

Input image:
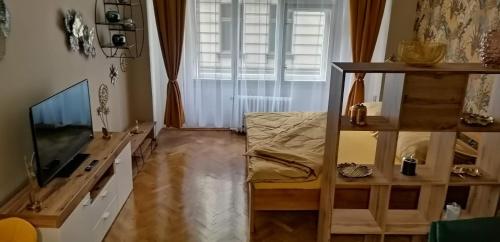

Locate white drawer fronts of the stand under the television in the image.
[39,143,132,242]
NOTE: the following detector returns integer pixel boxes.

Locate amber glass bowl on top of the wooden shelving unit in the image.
[398,41,446,67]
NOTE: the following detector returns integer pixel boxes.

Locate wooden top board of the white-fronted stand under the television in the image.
[0,132,130,228]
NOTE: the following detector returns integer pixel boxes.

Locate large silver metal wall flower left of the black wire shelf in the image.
[64,9,96,58]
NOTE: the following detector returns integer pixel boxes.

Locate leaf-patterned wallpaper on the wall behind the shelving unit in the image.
[415,0,500,115]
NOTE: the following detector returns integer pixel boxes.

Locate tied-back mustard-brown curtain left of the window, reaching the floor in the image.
[154,0,186,128]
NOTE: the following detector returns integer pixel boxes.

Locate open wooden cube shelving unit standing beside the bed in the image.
[318,63,500,242]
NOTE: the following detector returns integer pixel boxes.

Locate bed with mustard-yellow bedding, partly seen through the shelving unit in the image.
[245,103,475,230]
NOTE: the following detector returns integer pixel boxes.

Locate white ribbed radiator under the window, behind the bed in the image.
[236,96,292,132]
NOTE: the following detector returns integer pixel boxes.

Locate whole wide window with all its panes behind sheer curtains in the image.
[196,0,329,81]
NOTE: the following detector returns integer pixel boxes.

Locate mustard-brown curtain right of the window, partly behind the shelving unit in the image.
[346,0,385,113]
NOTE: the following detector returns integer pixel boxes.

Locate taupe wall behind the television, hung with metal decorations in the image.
[0,0,134,203]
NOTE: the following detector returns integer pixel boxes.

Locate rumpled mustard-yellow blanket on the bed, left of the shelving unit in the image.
[246,113,326,181]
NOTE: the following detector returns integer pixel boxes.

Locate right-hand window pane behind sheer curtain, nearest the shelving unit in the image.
[285,10,328,81]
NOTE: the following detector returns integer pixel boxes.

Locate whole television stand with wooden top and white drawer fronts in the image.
[0,132,133,242]
